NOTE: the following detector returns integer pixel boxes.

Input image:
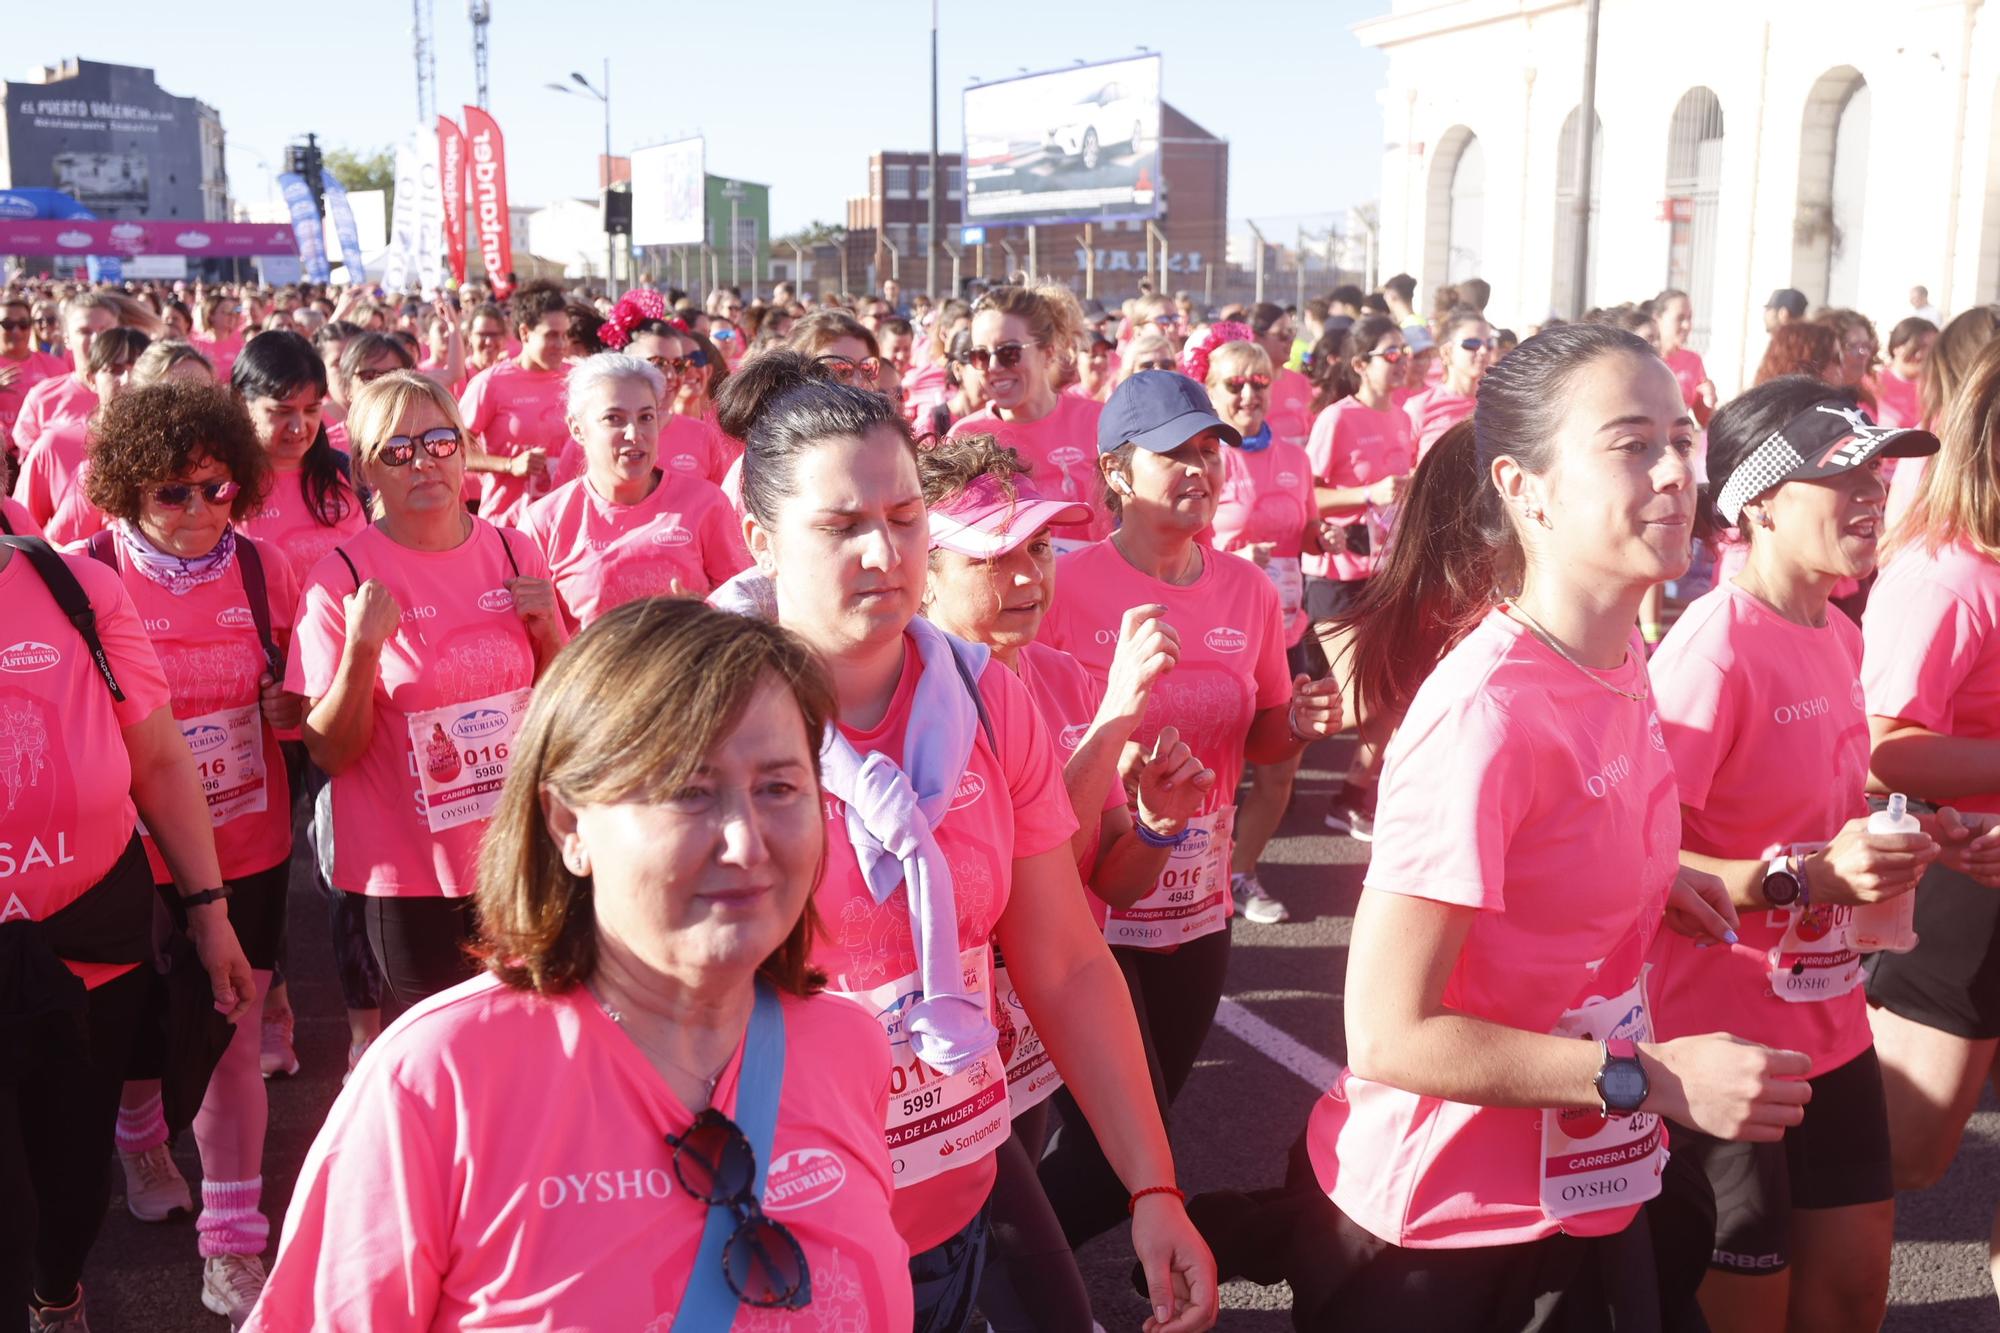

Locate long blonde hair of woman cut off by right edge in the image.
[1882,340,2000,560]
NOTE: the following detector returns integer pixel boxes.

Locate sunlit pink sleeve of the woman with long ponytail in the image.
[1364,695,1534,911]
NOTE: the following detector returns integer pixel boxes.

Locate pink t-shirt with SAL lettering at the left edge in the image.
[0,550,168,985]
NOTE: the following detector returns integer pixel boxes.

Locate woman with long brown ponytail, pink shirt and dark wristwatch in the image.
[1198,324,1810,1331]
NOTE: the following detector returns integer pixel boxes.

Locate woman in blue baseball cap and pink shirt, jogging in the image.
[1042,368,1340,1245]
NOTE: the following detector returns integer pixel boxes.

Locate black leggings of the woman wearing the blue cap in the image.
[1042,927,1230,1247]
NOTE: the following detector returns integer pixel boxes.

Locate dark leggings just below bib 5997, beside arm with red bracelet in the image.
[980,1101,1092,1333]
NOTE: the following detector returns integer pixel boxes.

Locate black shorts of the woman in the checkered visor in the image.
[1674,1047,1896,1277]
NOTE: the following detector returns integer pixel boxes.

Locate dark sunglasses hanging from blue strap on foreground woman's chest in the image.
[666,1107,812,1309]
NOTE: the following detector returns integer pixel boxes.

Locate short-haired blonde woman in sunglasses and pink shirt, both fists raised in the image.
[286,368,564,1003]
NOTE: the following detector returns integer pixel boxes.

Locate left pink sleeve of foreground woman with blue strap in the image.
[248,1059,452,1333]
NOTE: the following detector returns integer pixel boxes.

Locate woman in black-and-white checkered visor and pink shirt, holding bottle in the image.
[1648,376,1992,1333]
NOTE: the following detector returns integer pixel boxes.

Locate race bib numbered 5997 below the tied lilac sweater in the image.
[836,945,1014,1189]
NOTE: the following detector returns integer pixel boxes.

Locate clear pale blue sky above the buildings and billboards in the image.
[0,0,1388,240]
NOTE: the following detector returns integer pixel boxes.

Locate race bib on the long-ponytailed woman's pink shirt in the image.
[1542,975,1666,1221]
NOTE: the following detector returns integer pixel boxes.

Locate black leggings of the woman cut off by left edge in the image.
[0,965,154,1304]
